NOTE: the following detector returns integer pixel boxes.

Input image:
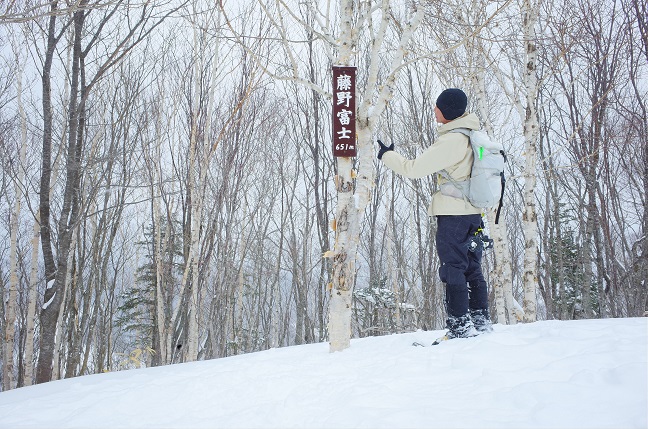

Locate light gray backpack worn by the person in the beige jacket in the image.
[439,128,506,219]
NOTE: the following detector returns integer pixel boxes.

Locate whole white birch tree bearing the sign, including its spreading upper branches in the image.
[221,0,424,351]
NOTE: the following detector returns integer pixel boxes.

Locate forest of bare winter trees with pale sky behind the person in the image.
[0,0,648,390]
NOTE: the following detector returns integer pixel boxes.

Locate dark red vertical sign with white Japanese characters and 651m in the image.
[333,67,356,157]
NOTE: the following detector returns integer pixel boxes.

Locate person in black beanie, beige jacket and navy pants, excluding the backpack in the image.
[378,88,493,339]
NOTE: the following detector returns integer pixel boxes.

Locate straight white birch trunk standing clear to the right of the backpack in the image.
[522,0,540,322]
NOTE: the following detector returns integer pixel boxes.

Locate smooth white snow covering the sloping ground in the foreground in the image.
[0,318,648,428]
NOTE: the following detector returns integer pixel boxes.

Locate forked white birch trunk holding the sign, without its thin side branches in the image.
[329,0,424,352]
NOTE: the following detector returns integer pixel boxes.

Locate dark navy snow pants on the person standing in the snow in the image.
[436,214,488,317]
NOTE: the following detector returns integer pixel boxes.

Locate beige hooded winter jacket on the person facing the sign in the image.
[382,113,481,216]
